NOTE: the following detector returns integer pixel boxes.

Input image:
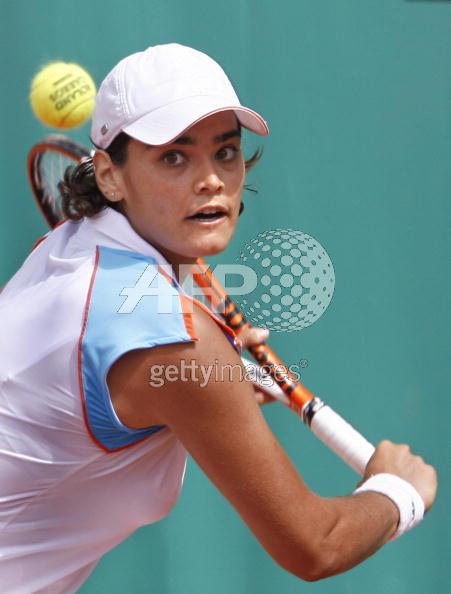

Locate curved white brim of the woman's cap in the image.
[123,95,269,146]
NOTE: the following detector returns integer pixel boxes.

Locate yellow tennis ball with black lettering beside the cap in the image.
[30,62,96,129]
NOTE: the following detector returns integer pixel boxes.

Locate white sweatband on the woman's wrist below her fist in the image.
[353,473,424,539]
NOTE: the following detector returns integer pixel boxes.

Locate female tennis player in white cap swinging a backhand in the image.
[0,44,436,594]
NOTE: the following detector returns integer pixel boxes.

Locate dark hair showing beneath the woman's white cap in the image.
[58,132,263,221]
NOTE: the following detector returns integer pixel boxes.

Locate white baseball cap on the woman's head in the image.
[91,43,269,149]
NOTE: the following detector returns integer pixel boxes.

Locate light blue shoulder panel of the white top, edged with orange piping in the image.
[82,247,193,450]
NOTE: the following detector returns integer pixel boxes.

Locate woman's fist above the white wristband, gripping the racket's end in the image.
[363,440,437,511]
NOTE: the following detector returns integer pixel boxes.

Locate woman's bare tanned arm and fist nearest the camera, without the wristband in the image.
[108,308,436,581]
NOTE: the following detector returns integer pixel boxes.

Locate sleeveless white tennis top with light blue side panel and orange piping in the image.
[0,208,238,594]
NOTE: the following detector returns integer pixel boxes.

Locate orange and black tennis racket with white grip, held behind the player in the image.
[27,135,374,475]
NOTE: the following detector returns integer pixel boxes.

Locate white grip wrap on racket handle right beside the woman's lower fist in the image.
[307,401,375,476]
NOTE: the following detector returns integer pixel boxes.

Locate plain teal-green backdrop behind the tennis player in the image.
[0,0,451,594]
